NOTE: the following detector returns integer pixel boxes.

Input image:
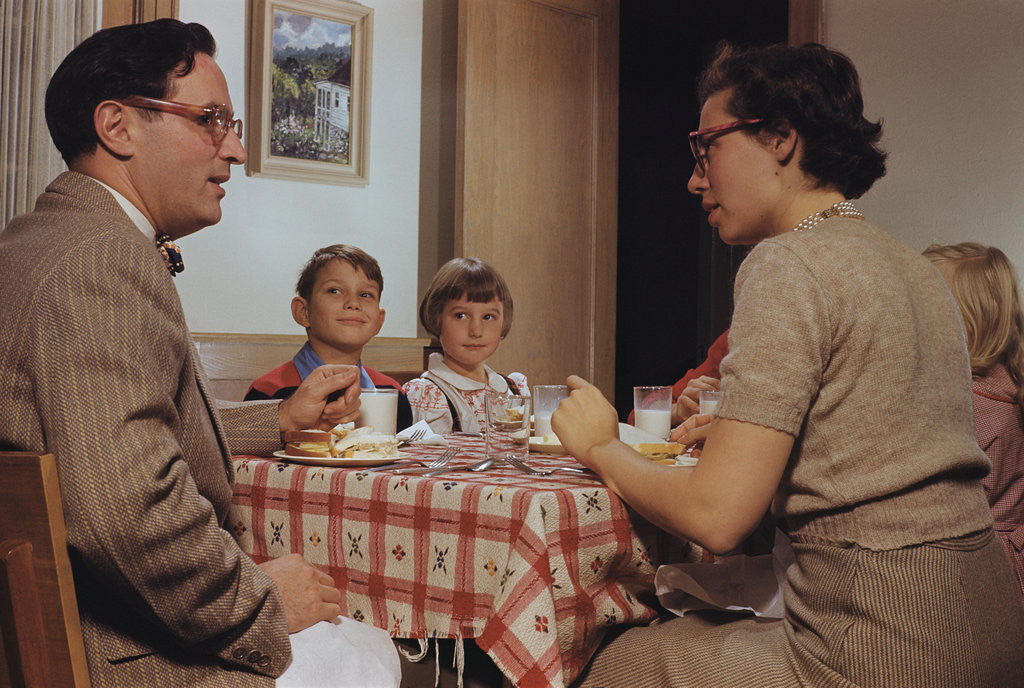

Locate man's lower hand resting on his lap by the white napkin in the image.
[258,554,341,633]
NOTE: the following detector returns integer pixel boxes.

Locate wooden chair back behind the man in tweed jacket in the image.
[0,452,90,688]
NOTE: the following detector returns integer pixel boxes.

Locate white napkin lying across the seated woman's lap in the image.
[654,529,794,618]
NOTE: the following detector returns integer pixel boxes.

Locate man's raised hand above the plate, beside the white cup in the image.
[278,364,359,433]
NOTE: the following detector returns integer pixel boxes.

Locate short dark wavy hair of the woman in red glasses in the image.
[697,42,886,199]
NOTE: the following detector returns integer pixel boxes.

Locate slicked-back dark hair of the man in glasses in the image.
[46,19,217,165]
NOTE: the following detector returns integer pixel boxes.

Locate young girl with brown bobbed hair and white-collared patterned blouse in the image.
[402,258,529,433]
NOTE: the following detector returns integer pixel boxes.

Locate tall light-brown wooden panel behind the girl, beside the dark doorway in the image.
[455,0,618,393]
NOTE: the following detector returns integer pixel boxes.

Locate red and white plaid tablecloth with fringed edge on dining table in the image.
[228,436,702,687]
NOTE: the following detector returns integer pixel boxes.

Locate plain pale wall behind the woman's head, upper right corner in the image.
[825,0,1024,276]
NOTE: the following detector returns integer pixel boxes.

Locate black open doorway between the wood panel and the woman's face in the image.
[614,0,788,419]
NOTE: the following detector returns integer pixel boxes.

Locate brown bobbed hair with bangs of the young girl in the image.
[420,258,513,337]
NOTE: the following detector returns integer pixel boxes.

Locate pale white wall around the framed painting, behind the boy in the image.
[175,0,423,337]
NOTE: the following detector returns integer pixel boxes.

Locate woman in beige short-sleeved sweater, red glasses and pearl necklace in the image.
[553,45,1024,688]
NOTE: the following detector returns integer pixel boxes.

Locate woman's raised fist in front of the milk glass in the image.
[551,375,618,466]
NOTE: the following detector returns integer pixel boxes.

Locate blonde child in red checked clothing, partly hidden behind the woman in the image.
[925,242,1024,596]
